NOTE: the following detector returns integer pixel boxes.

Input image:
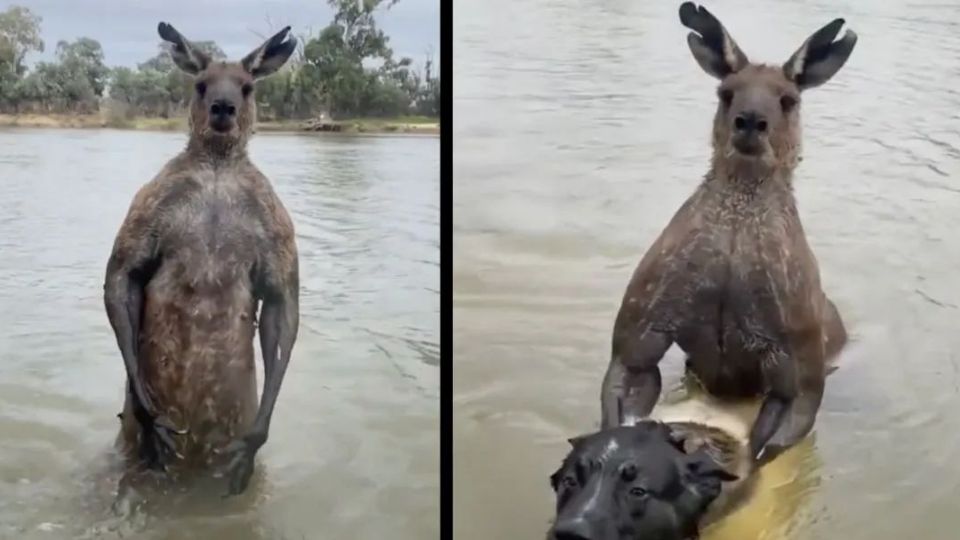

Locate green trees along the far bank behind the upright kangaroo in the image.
[0,0,440,120]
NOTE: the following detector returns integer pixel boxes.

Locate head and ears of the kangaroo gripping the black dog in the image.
[680,2,857,175]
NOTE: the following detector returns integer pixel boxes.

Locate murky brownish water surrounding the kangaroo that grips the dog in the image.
[453,0,960,540]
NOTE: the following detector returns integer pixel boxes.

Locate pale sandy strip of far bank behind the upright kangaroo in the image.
[0,113,440,135]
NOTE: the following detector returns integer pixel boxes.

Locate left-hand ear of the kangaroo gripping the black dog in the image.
[680,2,750,79]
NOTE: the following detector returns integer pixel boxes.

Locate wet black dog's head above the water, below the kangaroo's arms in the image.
[547,420,752,540]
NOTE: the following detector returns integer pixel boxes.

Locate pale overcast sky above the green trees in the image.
[0,0,440,67]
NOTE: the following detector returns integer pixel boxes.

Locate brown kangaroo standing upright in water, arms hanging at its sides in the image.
[104,22,299,495]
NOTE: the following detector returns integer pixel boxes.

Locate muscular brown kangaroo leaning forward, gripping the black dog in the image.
[601,2,857,460]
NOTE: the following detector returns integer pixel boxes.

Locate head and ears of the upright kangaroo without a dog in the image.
[157,22,297,152]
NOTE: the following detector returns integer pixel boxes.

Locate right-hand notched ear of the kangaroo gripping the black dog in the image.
[783,19,857,90]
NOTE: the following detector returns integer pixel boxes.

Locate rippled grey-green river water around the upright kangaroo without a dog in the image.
[0,130,439,540]
